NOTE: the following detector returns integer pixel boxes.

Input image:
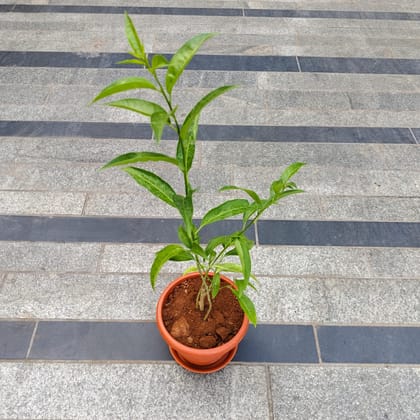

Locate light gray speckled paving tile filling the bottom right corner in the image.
[270,366,420,420]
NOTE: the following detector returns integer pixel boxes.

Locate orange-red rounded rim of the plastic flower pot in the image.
[156,271,249,356]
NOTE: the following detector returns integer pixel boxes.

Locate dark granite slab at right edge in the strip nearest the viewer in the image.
[318,326,420,364]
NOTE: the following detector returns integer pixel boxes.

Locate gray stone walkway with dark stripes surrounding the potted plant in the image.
[0,0,420,420]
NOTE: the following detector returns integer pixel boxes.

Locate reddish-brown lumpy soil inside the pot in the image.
[162,278,244,349]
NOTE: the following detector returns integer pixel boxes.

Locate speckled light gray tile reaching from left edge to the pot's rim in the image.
[0,272,167,320]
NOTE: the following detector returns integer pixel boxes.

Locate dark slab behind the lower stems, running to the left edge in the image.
[0,216,255,243]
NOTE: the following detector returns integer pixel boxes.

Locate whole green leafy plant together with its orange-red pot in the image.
[92,13,303,372]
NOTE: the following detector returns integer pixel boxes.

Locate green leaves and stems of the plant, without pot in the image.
[92,13,303,325]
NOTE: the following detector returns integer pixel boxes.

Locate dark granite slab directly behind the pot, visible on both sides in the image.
[29,321,318,363]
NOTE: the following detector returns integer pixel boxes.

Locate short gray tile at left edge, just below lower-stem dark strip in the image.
[0,242,100,272]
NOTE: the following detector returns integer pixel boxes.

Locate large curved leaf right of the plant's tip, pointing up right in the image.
[166,33,215,94]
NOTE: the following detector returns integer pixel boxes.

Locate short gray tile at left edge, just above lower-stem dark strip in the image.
[0,191,86,215]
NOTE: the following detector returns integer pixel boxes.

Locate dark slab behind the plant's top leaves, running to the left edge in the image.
[0,51,298,72]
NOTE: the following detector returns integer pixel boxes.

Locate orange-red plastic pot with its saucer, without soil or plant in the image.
[156,273,249,373]
